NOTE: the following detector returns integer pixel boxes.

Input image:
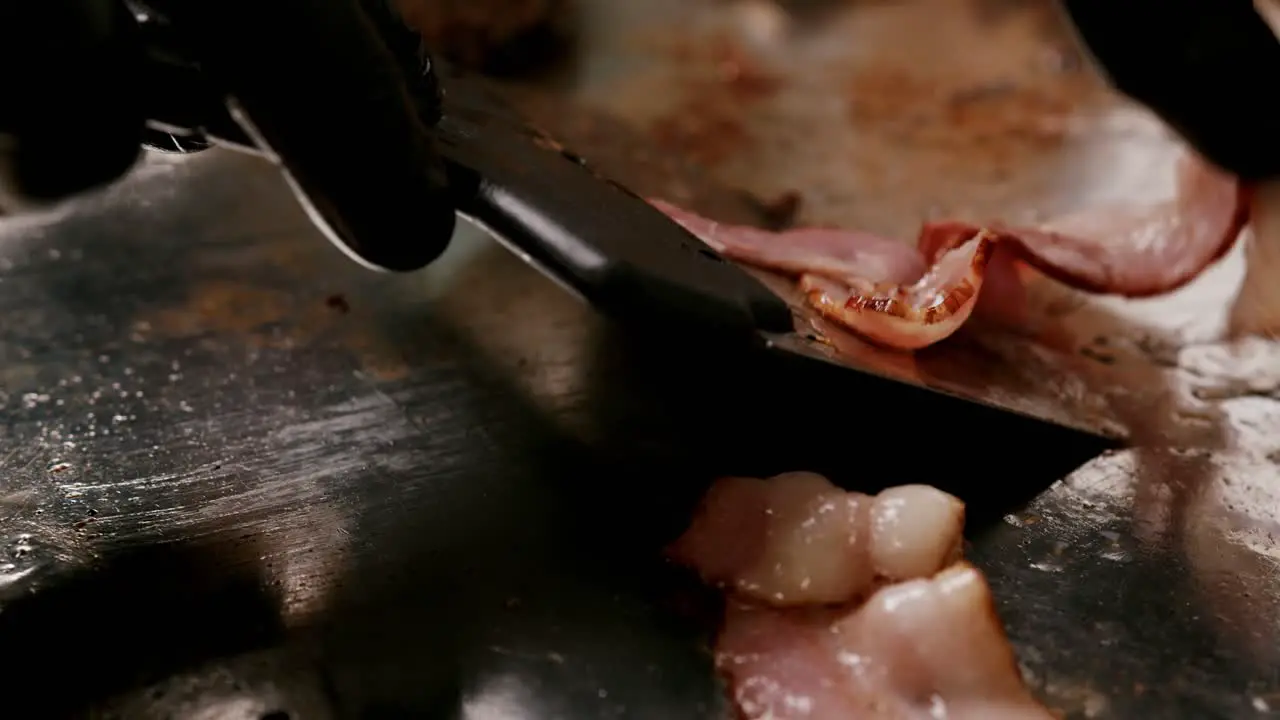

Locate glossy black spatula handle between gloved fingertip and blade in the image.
[435,70,794,333]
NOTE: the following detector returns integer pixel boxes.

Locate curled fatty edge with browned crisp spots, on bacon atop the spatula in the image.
[800,229,996,350]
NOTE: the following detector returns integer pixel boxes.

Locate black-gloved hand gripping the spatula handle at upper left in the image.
[0,0,454,270]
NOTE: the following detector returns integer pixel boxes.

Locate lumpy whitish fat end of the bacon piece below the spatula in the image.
[668,473,964,606]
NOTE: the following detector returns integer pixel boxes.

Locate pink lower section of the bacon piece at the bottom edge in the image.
[716,564,1053,720]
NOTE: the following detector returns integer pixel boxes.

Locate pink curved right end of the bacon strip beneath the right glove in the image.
[918,155,1249,297]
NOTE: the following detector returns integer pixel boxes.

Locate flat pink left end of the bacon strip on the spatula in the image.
[650,200,925,283]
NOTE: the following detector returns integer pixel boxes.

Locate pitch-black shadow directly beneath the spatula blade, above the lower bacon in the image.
[576,322,1112,529]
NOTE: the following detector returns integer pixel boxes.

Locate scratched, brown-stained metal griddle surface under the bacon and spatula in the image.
[0,0,1280,720]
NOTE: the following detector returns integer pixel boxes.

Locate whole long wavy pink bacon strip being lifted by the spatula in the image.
[652,155,1249,350]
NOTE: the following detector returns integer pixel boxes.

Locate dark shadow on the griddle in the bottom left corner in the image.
[0,542,283,720]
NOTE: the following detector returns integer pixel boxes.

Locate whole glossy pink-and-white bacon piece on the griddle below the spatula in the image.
[668,473,1051,720]
